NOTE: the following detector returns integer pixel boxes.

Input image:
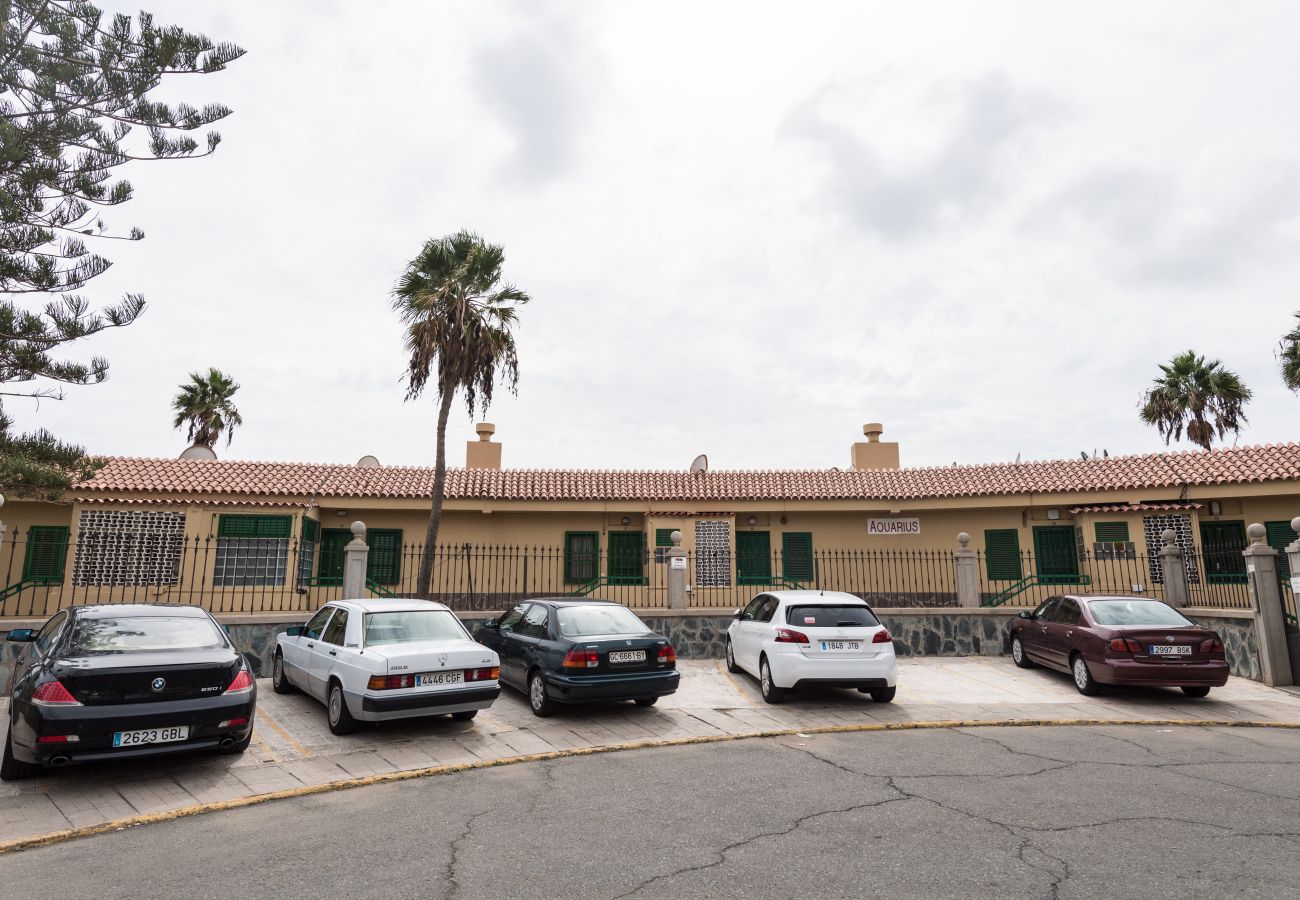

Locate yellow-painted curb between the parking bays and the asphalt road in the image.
[0,719,1300,856]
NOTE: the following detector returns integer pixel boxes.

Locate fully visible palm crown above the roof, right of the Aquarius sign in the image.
[1141,350,1251,450]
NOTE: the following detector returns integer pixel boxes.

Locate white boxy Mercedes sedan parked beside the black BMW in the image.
[272,600,501,735]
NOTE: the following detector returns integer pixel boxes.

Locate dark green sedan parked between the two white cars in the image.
[475,597,680,715]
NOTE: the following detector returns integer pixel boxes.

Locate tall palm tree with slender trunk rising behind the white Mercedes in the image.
[393,232,529,597]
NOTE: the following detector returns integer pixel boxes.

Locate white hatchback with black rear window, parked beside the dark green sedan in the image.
[727,590,898,704]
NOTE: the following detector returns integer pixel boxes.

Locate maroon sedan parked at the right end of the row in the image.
[1011,596,1227,697]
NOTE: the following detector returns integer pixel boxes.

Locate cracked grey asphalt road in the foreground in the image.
[0,727,1300,900]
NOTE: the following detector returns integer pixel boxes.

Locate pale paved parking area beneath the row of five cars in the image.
[0,657,1300,841]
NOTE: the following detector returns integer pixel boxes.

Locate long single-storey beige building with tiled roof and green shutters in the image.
[0,425,1300,616]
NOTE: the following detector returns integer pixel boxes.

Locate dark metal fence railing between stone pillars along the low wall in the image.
[0,527,1263,616]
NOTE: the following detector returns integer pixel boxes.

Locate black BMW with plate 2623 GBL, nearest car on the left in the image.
[0,605,257,782]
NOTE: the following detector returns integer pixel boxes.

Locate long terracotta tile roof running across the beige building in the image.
[77,443,1300,509]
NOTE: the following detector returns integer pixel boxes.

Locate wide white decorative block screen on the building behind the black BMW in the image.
[73,510,185,585]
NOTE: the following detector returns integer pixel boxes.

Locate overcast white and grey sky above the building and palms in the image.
[5,0,1300,470]
